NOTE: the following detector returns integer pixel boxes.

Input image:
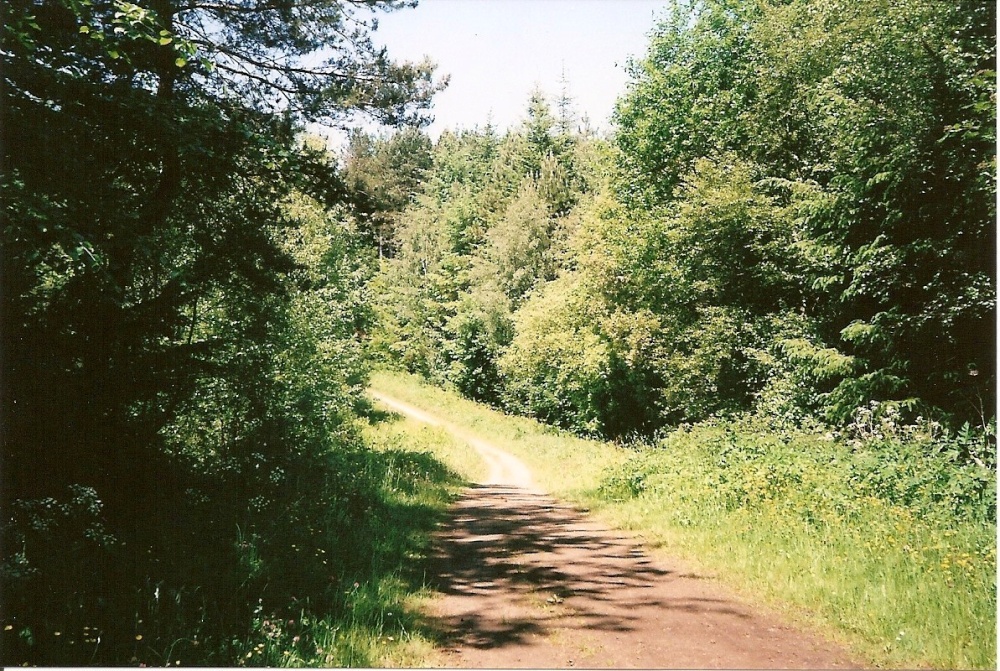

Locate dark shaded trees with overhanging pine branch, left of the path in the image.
[0,0,437,665]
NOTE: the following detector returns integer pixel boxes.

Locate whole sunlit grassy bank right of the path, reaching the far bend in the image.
[372,373,997,668]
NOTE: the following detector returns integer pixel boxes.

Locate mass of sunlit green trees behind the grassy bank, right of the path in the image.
[366,0,996,434]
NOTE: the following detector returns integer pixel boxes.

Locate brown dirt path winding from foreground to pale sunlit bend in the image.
[373,394,857,668]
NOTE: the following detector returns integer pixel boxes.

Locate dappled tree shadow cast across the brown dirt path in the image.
[427,485,747,649]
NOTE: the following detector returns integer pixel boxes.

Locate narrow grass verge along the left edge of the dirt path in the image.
[230,410,478,668]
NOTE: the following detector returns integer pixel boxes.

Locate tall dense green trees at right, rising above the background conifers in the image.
[606,0,996,424]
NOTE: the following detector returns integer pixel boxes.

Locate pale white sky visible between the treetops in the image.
[373,0,669,139]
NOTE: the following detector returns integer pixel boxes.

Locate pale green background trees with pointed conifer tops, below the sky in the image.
[370,86,606,410]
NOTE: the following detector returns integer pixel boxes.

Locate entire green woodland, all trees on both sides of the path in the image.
[0,0,997,666]
